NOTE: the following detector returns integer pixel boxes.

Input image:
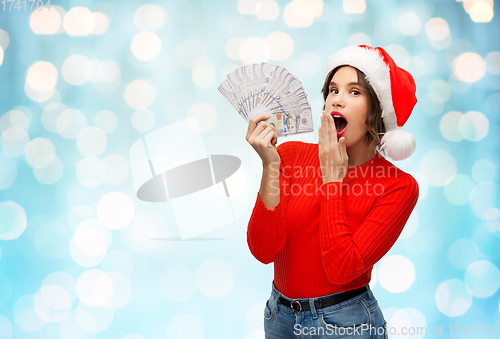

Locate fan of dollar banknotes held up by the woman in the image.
[218,62,314,136]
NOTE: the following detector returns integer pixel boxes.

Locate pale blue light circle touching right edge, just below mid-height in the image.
[469,182,500,220]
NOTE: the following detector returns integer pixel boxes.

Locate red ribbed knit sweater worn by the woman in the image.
[247,141,418,299]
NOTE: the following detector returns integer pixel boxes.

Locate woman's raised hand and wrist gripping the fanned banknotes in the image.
[246,113,280,166]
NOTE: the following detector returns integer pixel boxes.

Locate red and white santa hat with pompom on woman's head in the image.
[324,45,417,160]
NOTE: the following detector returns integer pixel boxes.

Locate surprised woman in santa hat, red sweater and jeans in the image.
[246,45,418,338]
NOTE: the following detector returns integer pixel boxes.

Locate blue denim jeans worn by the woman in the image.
[264,282,388,339]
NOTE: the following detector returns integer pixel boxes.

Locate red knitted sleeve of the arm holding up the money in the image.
[247,141,300,264]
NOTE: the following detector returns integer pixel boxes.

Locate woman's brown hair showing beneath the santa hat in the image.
[321,65,385,153]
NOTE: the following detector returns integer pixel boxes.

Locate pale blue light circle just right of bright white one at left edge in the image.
[35,221,72,259]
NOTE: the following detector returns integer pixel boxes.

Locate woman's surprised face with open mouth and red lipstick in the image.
[325,66,368,148]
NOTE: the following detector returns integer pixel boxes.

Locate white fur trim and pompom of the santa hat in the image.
[323,46,416,161]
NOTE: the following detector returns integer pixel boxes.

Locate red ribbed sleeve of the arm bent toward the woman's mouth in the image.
[319,174,419,285]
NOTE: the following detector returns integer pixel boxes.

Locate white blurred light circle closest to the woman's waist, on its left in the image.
[196,259,234,297]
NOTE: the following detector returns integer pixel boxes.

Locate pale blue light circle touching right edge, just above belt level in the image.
[464,260,500,298]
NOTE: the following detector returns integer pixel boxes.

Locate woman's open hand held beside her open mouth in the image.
[318,111,349,184]
